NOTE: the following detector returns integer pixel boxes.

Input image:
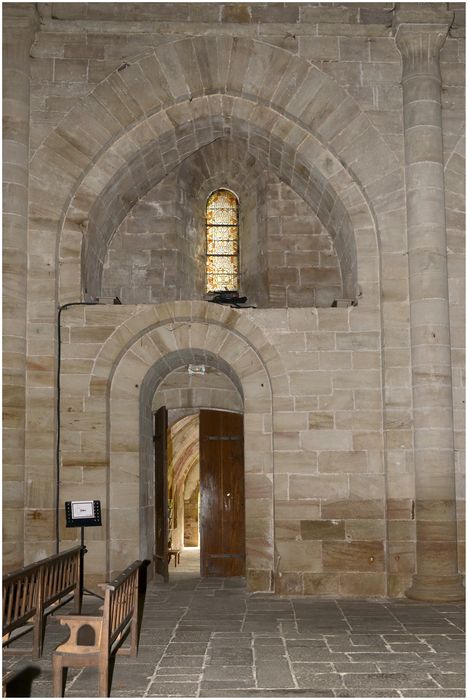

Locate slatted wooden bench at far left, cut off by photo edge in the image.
[2,545,82,659]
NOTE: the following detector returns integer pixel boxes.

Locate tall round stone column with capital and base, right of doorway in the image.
[395,8,464,600]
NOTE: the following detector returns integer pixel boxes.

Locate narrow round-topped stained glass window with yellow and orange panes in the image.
[206,189,239,292]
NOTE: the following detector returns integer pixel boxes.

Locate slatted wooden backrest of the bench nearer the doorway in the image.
[101,561,142,650]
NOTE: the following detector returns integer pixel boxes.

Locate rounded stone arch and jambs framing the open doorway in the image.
[89,302,288,590]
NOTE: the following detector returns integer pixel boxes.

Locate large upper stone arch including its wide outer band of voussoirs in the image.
[26,37,402,303]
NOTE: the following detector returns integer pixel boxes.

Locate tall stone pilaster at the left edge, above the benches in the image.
[3,3,37,570]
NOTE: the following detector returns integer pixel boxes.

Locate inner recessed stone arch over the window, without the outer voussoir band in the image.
[70,102,372,299]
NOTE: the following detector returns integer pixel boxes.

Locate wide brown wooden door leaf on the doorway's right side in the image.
[200,411,245,576]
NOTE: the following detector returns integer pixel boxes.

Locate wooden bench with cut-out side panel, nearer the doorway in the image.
[52,561,142,698]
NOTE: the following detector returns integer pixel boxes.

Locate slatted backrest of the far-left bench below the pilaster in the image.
[2,545,81,635]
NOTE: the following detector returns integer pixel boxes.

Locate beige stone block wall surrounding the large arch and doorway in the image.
[4,3,464,595]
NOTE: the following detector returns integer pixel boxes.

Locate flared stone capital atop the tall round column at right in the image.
[393,3,453,81]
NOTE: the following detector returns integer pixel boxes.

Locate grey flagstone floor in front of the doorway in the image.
[4,550,465,698]
